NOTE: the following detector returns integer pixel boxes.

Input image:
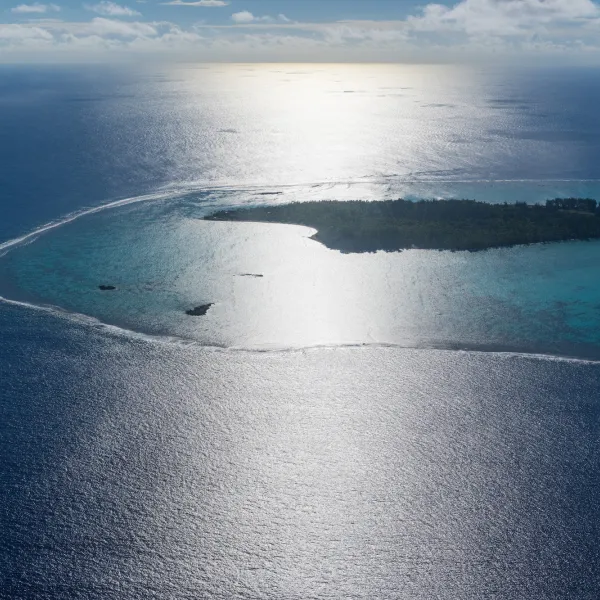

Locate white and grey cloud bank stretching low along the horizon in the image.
[0,0,600,64]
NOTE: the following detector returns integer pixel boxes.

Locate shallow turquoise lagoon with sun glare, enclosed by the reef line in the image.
[0,188,600,356]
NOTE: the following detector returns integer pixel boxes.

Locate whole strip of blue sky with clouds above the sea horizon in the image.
[0,0,600,64]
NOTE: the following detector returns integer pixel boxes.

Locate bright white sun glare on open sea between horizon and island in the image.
[166,64,476,185]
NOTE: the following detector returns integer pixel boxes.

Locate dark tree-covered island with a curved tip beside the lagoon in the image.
[206,198,600,252]
